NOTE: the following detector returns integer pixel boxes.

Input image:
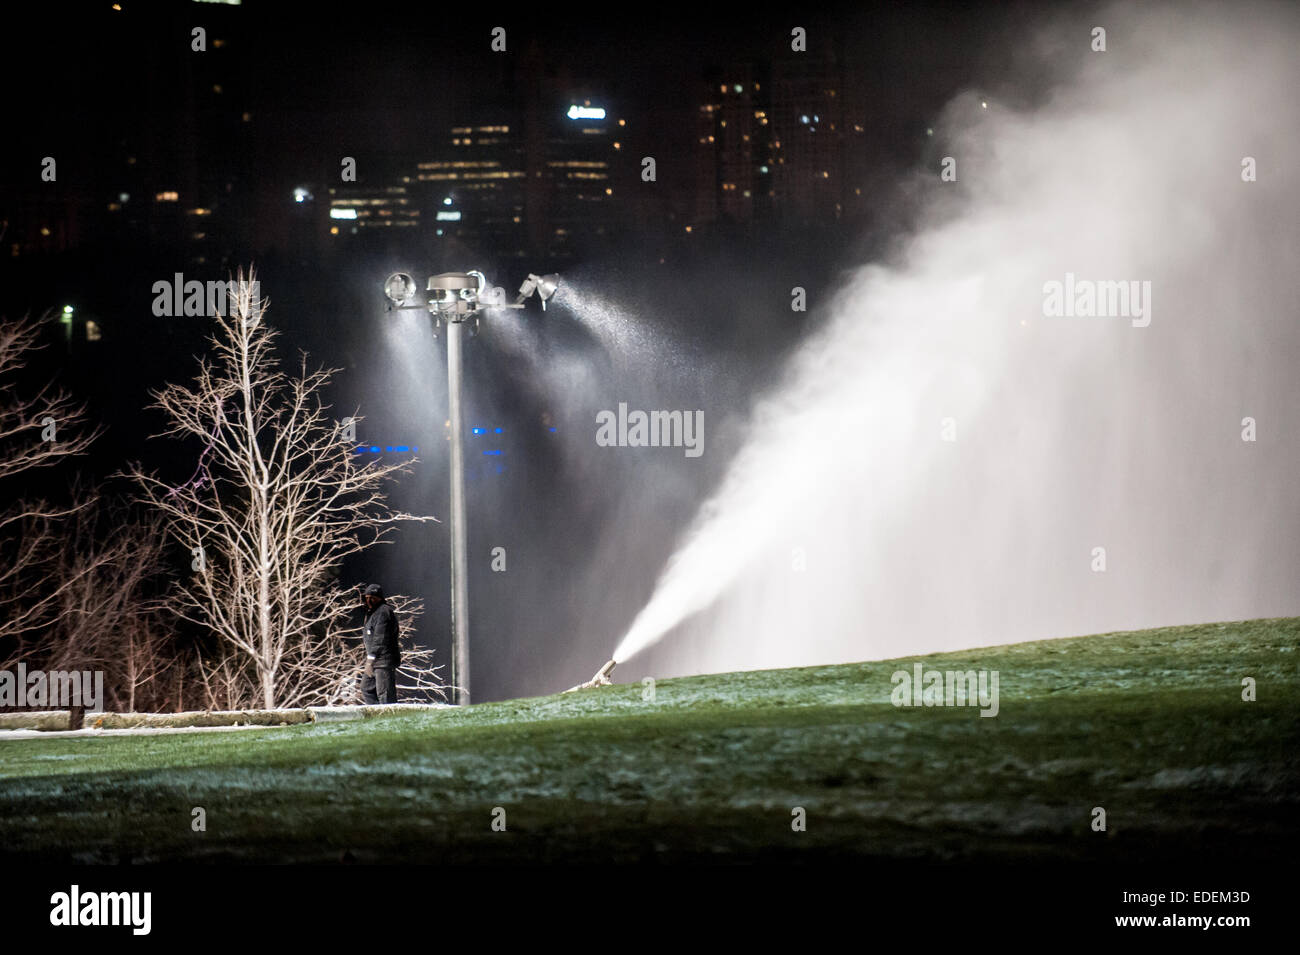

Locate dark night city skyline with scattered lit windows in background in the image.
[0,3,1008,268]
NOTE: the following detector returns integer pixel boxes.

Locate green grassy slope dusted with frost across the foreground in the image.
[0,618,1300,863]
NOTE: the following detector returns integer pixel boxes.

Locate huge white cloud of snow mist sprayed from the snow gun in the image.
[615,4,1300,673]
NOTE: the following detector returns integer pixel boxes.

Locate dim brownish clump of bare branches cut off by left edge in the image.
[0,313,187,709]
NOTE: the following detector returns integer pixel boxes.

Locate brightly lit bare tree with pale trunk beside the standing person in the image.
[130,272,437,708]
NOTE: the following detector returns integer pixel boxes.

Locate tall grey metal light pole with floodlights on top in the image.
[384,272,560,706]
